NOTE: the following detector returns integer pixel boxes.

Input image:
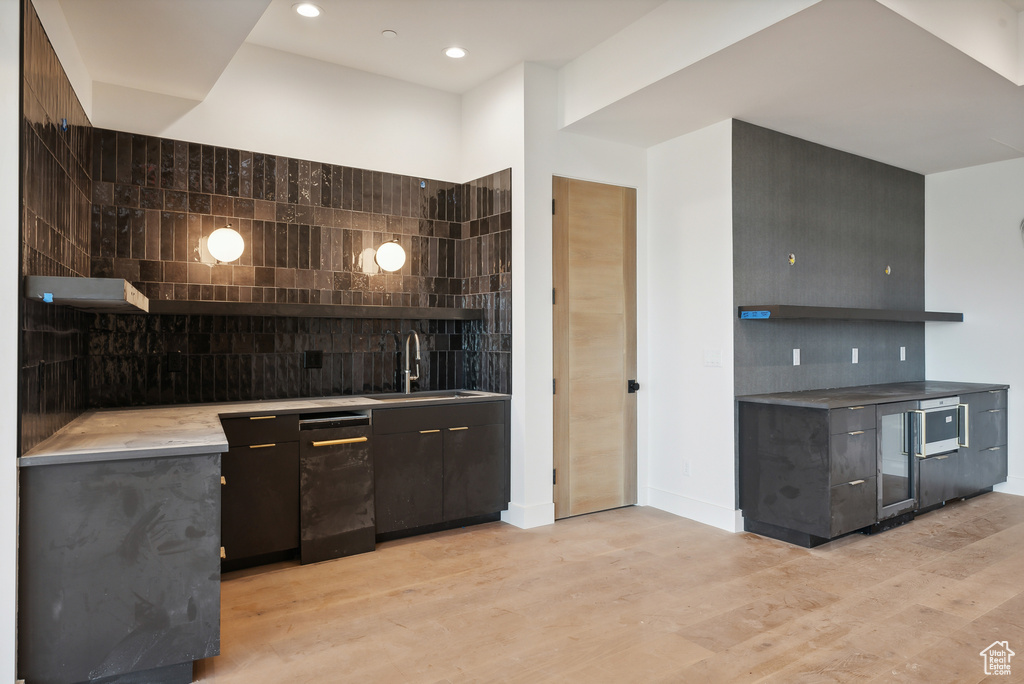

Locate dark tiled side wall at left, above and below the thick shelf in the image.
[17,0,92,452]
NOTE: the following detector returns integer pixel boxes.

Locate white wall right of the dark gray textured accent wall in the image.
[925,159,1024,496]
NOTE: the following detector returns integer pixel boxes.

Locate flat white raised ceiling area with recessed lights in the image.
[248,0,674,93]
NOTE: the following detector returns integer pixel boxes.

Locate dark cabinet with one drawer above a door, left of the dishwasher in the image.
[220,415,299,570]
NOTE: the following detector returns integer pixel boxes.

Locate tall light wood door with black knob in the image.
[552,176,636,518]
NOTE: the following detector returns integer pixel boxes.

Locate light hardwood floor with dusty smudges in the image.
[196,494,1024,684]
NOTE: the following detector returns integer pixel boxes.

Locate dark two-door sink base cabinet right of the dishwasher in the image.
[374,401,509,535]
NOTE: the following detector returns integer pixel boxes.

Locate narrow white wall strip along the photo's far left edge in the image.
[0,0,22,682]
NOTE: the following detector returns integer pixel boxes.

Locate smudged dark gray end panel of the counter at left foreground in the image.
[17,454,221,684]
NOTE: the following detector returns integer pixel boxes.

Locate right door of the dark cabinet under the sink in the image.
[443,425,509,520]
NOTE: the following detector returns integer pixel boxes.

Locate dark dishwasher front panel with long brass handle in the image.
[299,427,375,563]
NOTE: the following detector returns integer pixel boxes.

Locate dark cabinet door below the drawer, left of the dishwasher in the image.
[220,441,299,567]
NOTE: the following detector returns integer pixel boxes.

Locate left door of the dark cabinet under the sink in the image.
[373,429,442,535]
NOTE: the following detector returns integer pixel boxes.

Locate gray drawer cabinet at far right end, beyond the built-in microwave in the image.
[958,390,1007,496]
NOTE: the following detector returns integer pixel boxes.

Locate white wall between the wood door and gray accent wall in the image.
[641,121,739,530]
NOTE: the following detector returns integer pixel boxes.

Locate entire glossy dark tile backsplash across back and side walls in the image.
[19,0,511,453]
